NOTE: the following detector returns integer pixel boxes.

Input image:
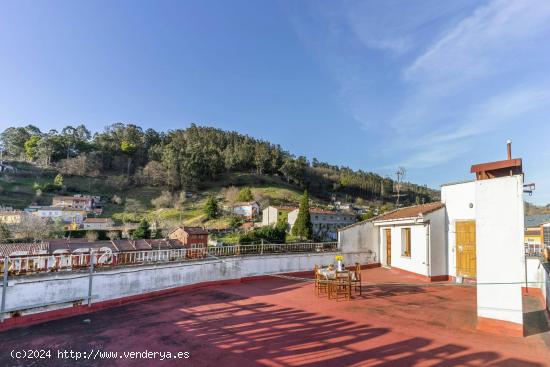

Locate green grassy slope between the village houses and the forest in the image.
[0,163,312,228]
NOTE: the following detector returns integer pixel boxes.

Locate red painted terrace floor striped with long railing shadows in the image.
[0,268,550,367]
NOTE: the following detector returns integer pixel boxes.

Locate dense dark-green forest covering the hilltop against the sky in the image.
[0,123,439,204]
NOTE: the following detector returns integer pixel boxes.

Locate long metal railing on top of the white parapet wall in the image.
[0,242,338,275]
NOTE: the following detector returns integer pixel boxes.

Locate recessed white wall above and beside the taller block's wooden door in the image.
[441,181,476,276]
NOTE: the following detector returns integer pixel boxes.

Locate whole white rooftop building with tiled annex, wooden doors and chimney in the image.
[339,142,525,335]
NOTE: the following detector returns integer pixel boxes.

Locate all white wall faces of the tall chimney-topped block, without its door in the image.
[441,175,525,324]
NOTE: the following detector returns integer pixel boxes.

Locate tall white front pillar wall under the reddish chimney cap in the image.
[475,175,525,324]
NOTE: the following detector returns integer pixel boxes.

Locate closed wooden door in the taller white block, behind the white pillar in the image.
[455,220,477,278]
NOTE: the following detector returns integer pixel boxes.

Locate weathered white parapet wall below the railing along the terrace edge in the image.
[4,252,372,318]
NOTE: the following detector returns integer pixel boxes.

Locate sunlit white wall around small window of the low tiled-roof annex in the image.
[379,222,428,275]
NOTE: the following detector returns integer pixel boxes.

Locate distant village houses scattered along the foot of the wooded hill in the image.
[0,187,368,255]
